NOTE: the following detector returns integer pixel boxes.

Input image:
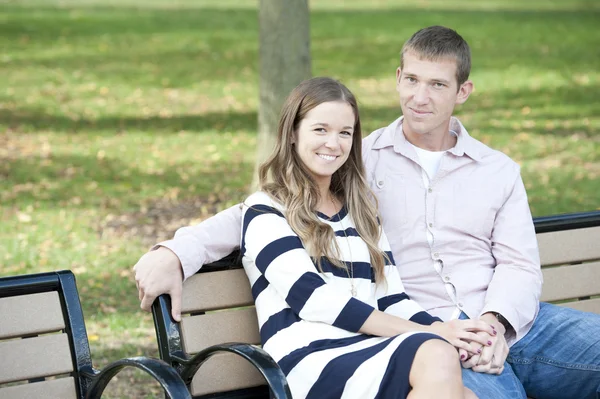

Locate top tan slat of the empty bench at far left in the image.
[0,292,65,339]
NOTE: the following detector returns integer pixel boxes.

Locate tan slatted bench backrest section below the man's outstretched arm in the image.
[153,253,268,398]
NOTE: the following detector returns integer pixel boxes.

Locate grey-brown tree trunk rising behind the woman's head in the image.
[252,0,311,191]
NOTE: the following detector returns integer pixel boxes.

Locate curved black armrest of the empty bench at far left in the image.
[82,357,192,399]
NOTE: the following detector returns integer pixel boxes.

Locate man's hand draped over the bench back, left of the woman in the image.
[133,247,183,321]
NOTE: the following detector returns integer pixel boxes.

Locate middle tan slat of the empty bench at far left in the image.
[0,334,73,384]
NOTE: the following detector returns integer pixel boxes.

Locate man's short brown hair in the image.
[400,26,471,86]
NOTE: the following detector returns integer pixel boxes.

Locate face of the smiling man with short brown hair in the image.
[396,52,472,139]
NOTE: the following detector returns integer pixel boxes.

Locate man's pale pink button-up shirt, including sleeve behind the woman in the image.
[159,118,542,345]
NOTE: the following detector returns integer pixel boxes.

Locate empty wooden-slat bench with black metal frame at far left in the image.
[0,271,191,399]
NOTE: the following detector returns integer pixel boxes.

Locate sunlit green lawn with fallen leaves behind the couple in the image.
[0,0,600,397]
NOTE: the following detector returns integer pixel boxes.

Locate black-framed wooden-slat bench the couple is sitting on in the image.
[152,211,600,398]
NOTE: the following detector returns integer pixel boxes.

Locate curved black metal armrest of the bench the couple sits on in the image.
[181,342,292,399]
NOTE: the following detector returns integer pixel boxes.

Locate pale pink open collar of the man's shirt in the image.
[373,116,481,162]
